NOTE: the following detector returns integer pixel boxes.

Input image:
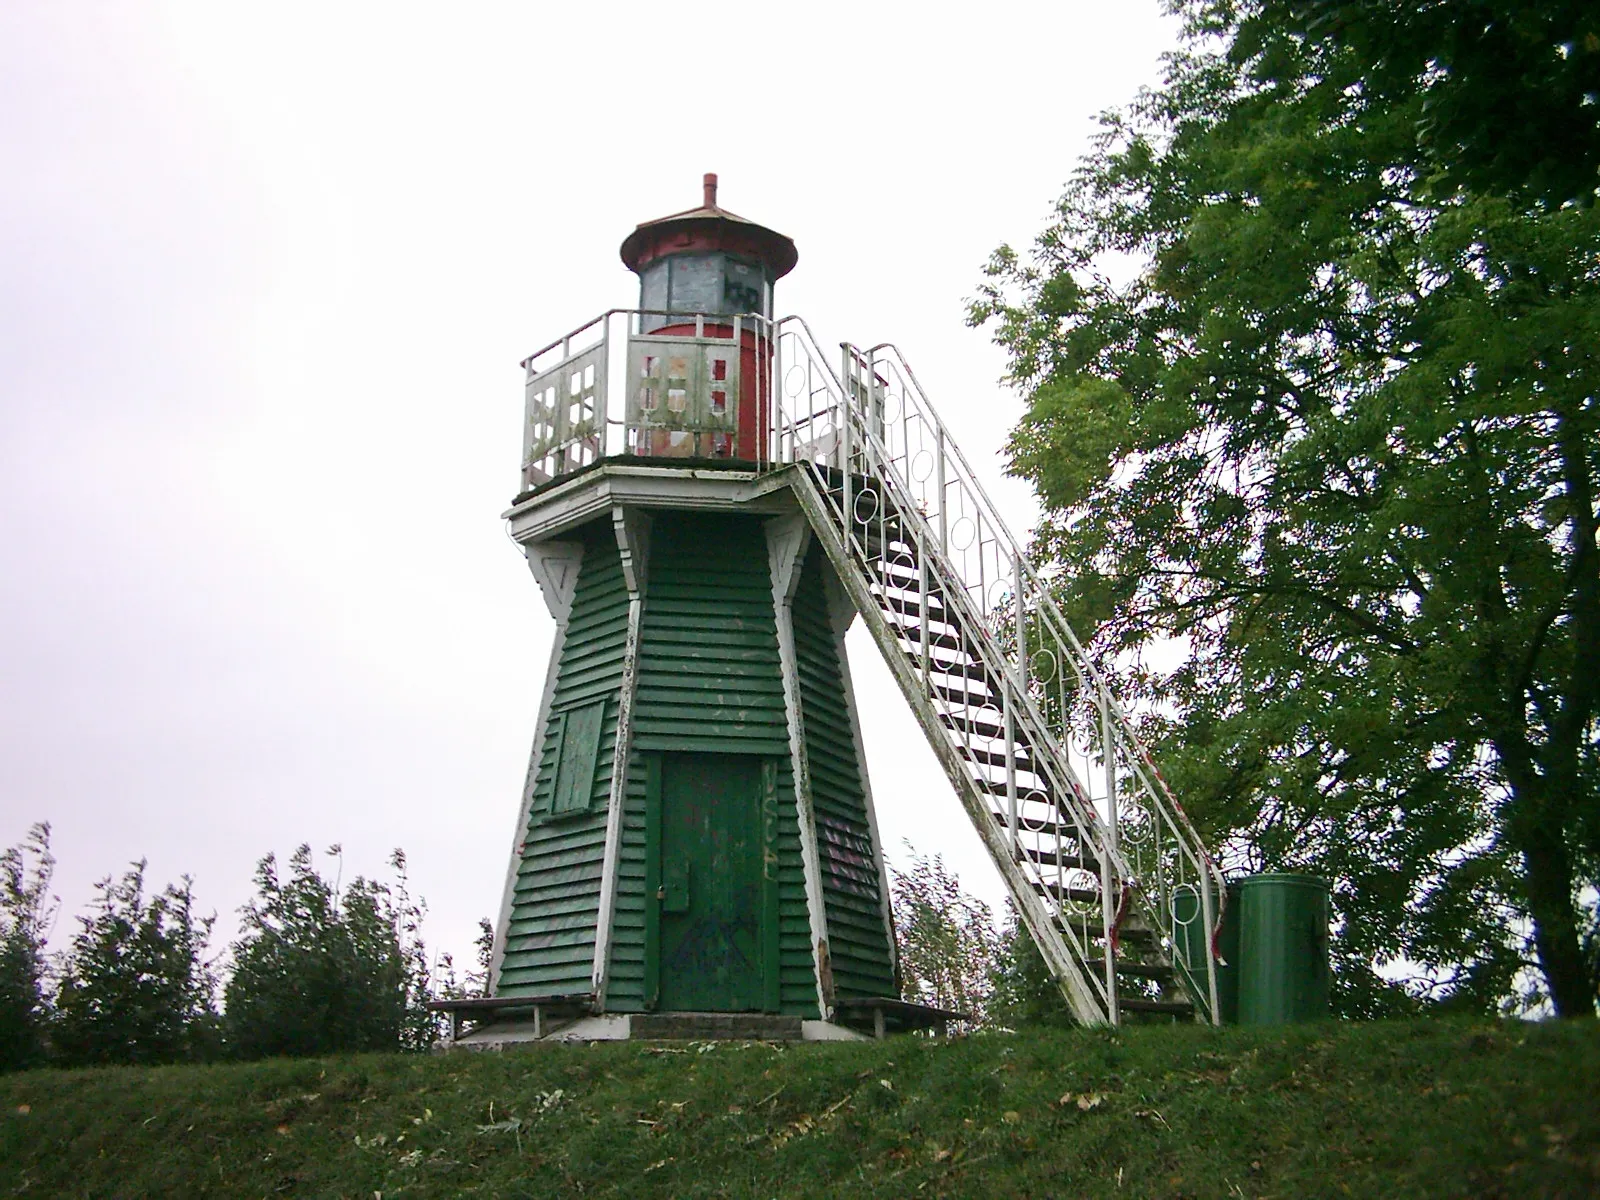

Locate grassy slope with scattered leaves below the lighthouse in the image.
[0,1021,1600,1200]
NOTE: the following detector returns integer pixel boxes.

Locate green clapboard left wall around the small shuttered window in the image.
[496,520,627,995]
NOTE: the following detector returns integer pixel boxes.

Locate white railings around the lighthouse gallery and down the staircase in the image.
[523,309,1226,1022]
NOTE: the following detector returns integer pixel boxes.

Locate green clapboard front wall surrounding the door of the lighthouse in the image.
[606,514,818,1016]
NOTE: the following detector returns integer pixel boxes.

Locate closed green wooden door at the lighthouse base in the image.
[656,754,766,1013]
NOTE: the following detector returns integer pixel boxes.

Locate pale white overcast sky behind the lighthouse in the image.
[0,0,1176,960]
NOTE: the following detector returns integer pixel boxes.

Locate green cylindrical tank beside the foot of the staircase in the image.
[1238,875,1331,1026]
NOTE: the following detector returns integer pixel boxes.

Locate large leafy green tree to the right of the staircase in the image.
[971,0,1600,1016]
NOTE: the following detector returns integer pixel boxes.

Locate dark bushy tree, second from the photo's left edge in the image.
[53,861,216,1066]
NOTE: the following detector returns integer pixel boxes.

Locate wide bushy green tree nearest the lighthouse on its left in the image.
[224,845,437,1058]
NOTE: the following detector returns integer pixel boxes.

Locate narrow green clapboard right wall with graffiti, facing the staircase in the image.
[792,541,898,998]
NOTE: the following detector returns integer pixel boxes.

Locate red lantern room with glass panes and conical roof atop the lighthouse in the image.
[622,174,800,462]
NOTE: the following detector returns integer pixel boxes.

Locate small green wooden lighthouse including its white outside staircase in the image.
[446,174,1221,1045]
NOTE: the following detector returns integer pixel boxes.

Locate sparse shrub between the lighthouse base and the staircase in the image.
[890,843,1000,1021]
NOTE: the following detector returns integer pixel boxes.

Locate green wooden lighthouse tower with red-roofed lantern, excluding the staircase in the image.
[467,176,898,1037]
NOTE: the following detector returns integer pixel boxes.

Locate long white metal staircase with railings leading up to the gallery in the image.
[771,318,1226,1024]
